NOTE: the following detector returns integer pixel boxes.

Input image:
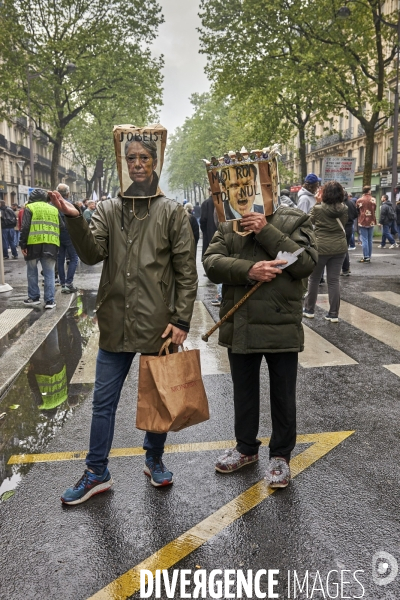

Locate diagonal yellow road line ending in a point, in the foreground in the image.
[88,431,354,600]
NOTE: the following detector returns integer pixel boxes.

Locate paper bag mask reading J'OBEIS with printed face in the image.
[113,124,167,198]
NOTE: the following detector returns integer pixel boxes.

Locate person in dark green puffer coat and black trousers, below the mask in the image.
[204,207,318,488]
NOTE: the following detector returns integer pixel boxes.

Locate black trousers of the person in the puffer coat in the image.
[228,350,298,460]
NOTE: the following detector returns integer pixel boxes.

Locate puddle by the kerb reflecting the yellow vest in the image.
[0,292,96,499]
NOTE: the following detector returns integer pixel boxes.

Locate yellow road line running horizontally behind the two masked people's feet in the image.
[7,433,346,465]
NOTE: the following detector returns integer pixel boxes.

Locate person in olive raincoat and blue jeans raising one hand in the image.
[52,135,197,505]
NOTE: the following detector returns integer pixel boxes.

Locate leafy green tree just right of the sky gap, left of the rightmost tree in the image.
[200,0,333,177]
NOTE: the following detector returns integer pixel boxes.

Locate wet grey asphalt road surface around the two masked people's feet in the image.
[0,245,400,600]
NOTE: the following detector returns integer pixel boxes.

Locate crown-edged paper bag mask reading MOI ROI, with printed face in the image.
[205,148,279,223]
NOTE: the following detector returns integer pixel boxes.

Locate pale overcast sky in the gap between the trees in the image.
[153,0,210,133]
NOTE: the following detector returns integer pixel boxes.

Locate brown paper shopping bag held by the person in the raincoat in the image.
[136,340,210,433]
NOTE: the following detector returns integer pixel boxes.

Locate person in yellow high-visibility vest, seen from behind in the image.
[20,188,62,309]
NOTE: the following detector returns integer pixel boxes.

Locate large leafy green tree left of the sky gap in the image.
[0,0,163,187]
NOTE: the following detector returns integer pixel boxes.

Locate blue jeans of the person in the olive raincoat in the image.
[86,348,167,475]
